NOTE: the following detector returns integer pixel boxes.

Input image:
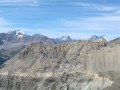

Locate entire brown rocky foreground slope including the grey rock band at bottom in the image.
[0,39,120,90]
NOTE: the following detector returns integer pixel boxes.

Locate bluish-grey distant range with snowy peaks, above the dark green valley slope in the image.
[0,30,109,49]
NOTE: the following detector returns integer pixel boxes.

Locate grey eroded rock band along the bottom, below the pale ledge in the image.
[0,72,113,90]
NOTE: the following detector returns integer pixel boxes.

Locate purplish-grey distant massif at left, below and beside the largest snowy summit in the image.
[0,30,56,49]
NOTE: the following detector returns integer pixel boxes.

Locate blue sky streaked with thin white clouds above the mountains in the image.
[0,0,120,39]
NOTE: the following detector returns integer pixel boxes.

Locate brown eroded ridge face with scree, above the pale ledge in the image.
[1,41,120,72]
